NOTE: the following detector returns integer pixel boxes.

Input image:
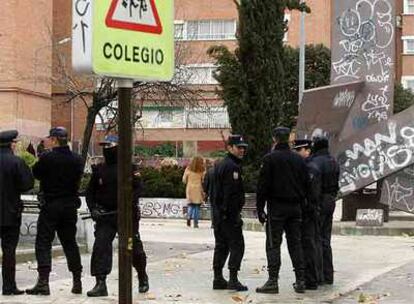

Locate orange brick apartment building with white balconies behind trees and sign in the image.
[0,0,414,153]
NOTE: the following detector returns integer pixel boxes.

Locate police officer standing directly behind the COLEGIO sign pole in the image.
[86,135,149,297]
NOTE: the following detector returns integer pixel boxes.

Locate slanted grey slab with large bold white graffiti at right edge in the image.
[337,108,414,194]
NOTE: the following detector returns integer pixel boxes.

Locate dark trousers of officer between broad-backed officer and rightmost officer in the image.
[302,211,319,286]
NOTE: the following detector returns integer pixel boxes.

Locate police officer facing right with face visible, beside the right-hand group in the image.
[212,135,248,291]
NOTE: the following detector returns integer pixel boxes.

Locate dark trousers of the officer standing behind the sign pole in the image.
[91,212,147,279]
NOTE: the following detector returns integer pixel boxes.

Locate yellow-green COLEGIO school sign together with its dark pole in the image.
[72,0,174,304]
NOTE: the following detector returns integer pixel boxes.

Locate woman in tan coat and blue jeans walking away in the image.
[183,156,205,228]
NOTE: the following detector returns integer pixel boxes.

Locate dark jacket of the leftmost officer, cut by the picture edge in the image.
[0,147,34,226]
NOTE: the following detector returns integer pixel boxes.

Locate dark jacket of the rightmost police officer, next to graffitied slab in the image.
[309,149,339,202]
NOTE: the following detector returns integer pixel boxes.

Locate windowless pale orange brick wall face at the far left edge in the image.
[0,0,52,137]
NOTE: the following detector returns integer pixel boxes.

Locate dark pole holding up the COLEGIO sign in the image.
[118,79,133,304]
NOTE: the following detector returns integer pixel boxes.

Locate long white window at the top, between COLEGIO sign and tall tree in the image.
[175,20,236,40]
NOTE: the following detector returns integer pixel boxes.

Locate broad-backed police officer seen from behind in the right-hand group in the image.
[256,127,309,293]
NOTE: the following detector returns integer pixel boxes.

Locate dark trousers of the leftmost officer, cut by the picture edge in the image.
[0,221,20,291]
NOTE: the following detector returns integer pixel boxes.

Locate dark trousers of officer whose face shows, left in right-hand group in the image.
[213,220,244,271]
